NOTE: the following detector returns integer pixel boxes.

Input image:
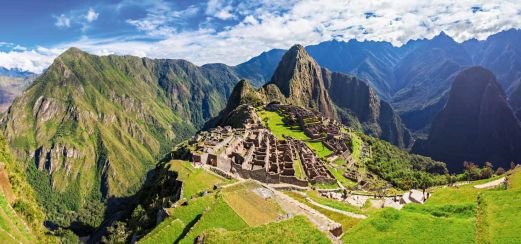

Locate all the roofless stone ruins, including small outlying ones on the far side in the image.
[189,106,347,186]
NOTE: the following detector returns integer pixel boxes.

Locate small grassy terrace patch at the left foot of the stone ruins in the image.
[167,160,227,198]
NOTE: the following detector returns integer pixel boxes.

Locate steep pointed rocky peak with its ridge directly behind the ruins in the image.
[214,45,412,148]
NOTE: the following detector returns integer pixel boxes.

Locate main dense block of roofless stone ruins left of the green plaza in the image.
[190,126,308,186]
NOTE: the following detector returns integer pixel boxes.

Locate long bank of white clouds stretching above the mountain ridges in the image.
[5,0,521,70]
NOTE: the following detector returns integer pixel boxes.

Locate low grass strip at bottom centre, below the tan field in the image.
[205,216,331,243]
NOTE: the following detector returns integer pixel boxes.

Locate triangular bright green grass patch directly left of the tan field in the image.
[181,196,248,243]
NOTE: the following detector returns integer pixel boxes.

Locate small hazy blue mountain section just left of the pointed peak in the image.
[234,49,286,87]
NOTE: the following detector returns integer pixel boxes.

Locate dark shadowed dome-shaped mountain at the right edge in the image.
[413,67,521,171]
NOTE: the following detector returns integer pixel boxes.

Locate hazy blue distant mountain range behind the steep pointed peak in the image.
[237,29,521,131]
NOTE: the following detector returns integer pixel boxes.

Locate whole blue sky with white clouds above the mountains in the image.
[0,0,521,73]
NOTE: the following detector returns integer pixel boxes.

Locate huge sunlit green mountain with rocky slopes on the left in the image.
[1,48,238,234]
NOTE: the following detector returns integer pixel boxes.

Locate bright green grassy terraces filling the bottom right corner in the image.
[342,173,521,243]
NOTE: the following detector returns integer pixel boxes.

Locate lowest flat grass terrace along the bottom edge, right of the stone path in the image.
[342,208,476,243]
